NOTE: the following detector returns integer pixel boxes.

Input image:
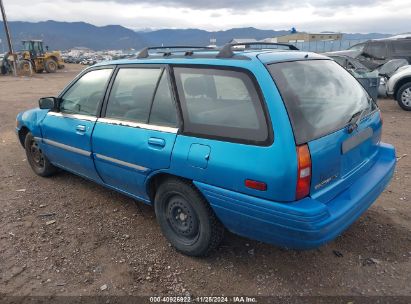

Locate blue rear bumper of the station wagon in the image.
[195,143,396,249]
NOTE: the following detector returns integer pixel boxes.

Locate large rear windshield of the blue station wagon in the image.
[269,60,373,144]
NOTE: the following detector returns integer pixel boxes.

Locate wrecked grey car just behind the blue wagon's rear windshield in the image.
[324,53,385,101]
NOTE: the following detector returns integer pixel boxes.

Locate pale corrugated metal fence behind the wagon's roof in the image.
[290,40,367,53]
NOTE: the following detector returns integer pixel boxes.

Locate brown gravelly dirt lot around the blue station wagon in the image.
[0,66,411,296]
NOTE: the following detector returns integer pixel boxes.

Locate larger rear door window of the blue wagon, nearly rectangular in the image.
[106,68,162,123]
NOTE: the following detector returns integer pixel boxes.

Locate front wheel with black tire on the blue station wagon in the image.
[24,132,57,177]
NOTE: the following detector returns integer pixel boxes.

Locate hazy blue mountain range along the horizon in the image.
[0,21,391,51]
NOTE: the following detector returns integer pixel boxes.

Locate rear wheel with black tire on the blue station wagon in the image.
[154,178,224,256]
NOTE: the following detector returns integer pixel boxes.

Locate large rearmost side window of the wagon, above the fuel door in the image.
[174,67,269,143]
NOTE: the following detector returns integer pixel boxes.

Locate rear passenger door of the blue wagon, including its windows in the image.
[92,65,178,200]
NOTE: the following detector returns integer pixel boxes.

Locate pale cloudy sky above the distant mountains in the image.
[3,0,411,33]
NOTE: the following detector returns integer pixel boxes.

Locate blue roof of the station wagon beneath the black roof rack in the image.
[95,49,330,66]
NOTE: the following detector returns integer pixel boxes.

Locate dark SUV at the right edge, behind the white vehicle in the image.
[329,38,411,70]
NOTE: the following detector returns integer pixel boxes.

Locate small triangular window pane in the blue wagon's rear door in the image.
[149,70,177,127]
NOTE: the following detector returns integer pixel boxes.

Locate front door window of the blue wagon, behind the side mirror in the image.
[60,69,113,116]
